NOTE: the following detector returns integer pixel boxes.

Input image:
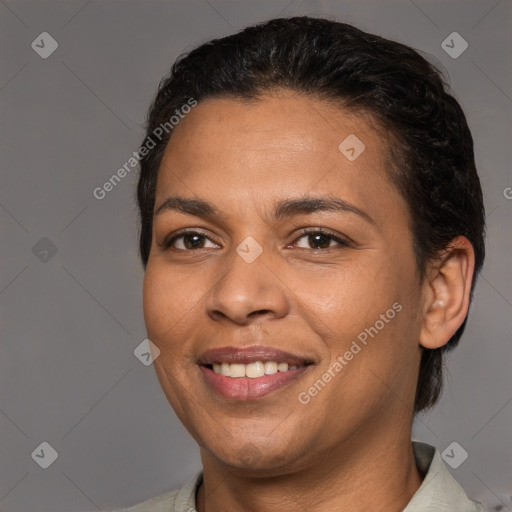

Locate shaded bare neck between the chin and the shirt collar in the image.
[196,422,423,512]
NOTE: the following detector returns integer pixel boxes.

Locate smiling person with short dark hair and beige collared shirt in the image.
[115,17,484,512]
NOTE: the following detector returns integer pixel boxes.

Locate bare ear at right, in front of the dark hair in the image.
[420,236,475,349]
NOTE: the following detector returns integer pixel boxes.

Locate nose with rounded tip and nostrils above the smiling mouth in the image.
[206,244,289,325]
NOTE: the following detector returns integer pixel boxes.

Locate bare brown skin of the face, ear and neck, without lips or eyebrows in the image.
[144,91,474,512]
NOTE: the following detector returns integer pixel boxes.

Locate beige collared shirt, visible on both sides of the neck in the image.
[117,441,486,512]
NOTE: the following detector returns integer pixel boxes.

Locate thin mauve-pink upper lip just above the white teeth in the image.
[198,345,312,366]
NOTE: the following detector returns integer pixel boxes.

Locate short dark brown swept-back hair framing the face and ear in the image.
[137,17,485,414]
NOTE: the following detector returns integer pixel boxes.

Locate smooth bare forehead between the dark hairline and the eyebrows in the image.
[156,91,398,226]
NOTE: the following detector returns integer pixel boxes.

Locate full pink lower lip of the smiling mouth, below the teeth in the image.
[199,366,308,400]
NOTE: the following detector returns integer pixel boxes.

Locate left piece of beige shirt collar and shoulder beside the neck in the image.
[110,471,203,512]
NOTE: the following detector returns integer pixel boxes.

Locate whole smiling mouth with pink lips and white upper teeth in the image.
[198,346,314,400]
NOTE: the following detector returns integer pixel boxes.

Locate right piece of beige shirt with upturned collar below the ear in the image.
[403,441,486,512]
